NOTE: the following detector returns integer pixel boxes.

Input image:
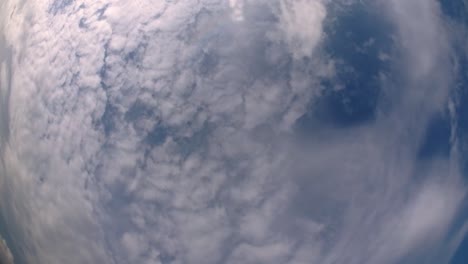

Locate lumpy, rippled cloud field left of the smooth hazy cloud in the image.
[2,1,332,263]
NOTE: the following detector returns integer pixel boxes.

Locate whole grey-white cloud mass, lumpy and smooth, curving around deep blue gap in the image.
[0,0,466,264]
